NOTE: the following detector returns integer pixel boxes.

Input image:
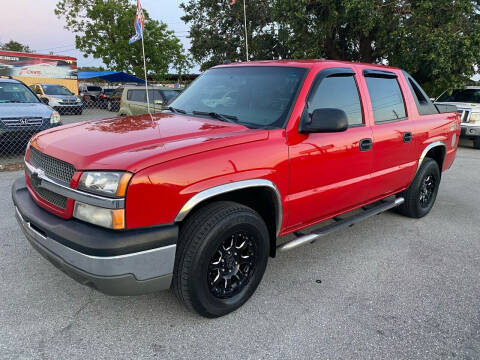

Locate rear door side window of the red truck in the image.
[365,76,407,124]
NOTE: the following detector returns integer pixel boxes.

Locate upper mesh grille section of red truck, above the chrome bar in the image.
[28,146,75,185]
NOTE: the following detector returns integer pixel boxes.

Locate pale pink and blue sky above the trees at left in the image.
[0,0,191,70]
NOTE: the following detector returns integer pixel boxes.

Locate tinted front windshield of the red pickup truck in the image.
[170,66,306,128]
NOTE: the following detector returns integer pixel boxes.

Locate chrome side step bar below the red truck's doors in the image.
[277,197,405,251]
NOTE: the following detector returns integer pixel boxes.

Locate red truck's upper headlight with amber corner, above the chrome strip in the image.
[78,171,132,197]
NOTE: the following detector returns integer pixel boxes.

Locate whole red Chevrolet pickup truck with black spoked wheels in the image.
[12,60,460,317]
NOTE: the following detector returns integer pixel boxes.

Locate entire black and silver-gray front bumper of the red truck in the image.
[12,179,178,295]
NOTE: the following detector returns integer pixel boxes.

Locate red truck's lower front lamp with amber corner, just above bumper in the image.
[73,201,125,230]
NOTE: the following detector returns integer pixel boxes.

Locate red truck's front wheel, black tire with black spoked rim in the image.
[172,201,270,318]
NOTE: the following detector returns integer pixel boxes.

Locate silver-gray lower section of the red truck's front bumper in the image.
[14,179,176,295]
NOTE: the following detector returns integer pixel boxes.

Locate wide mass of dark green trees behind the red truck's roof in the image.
[182,0,480,95]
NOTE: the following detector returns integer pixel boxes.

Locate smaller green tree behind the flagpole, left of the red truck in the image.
[55,0,191,80]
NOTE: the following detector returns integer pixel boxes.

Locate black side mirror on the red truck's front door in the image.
[299,108,348,134]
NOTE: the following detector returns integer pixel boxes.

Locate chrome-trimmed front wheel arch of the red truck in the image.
[175,179,283,257]
